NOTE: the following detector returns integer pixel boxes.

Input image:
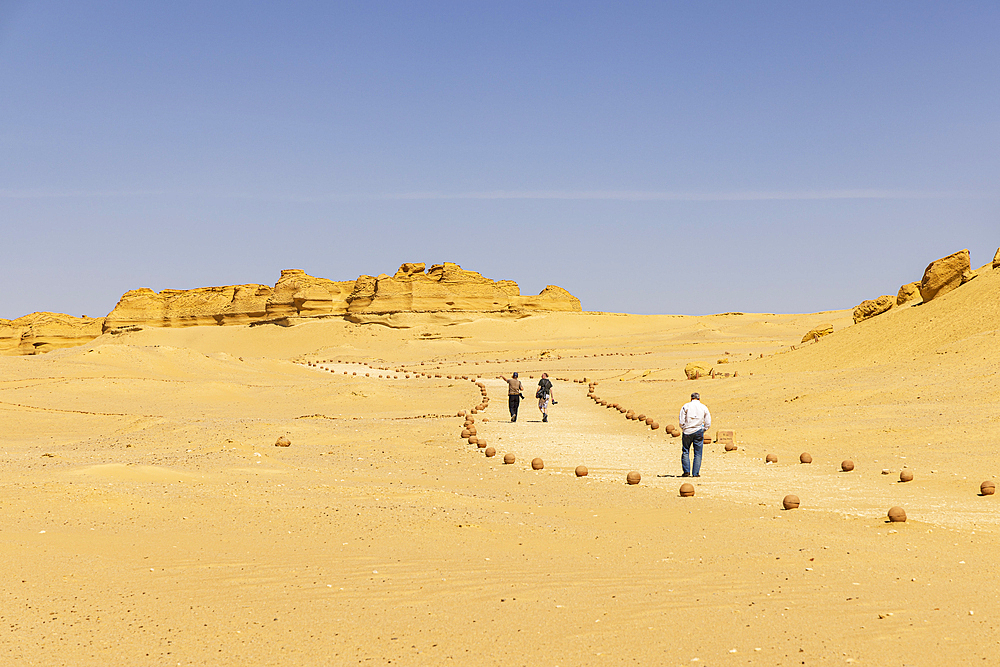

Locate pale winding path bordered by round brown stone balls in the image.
[300,362,1000,530]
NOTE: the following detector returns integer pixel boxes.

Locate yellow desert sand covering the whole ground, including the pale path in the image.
[0,272,1000,665]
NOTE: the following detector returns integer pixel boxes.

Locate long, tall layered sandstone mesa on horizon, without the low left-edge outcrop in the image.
[104,263,581,332]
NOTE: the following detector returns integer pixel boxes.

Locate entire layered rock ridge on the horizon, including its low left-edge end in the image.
[0,262,582,355]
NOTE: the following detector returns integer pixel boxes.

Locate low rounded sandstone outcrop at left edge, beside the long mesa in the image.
[0,313,104,355]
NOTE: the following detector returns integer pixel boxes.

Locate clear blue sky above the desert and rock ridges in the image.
[0,0,1000,318]
